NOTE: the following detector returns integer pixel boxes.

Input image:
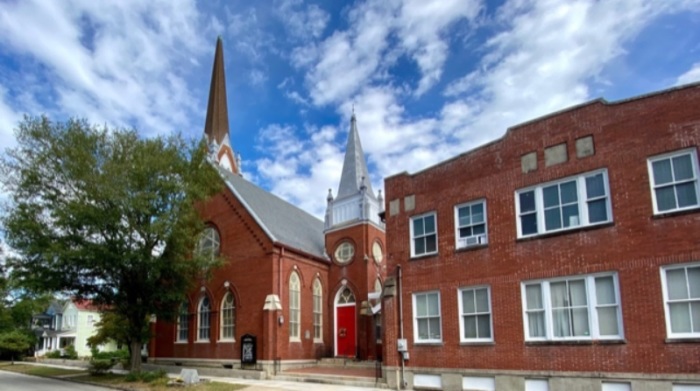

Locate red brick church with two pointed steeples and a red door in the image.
[149,38,386,372]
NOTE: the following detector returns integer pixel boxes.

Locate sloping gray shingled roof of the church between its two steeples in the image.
[219,169,327,259]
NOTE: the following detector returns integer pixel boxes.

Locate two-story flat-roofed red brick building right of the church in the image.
[383,84,700,391]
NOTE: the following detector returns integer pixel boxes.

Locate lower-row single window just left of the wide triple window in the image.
[457,286,493,342]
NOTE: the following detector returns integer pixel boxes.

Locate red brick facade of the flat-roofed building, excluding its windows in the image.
[385,85,700,373]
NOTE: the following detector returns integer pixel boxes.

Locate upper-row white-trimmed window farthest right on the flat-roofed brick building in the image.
[648,148,700,214]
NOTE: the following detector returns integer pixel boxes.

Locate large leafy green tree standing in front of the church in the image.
[0,117,221,372]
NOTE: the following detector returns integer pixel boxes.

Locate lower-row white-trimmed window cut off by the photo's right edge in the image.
[661,263,700,338]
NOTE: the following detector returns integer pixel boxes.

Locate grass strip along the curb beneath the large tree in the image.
[0,362,246,391]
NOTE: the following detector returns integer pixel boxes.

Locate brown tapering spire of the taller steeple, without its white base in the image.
[204,37,229,145]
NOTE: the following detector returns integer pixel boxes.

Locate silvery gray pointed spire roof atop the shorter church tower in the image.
[336,113,374,199]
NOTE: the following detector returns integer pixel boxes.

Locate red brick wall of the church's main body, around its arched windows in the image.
[153,190,328,360]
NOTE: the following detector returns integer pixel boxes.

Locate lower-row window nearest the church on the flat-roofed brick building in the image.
[413,292,442,343]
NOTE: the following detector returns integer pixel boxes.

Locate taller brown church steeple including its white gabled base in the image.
[204,36,241,174]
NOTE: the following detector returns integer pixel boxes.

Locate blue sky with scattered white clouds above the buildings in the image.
[0,0,700,218]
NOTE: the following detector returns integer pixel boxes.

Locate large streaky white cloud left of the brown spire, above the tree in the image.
[0,0,208,138]
